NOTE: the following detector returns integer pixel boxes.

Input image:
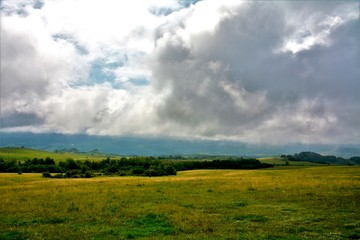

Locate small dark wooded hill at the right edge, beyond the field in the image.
[281,152,360,165]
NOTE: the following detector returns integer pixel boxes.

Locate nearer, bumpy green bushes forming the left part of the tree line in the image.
[0,157,176,178]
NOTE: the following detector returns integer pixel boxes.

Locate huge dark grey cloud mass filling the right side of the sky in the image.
[153,2,360,141]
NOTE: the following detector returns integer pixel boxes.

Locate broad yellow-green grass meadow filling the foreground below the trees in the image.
[0,166,360,239]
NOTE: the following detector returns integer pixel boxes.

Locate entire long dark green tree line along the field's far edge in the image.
[0,157,273,178]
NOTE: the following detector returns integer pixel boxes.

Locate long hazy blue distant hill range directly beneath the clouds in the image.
[0,132,360,158]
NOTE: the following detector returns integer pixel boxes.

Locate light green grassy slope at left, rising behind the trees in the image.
[0,148,114,162]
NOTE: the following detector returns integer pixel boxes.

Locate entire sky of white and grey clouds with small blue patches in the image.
[1,0,360,144]
